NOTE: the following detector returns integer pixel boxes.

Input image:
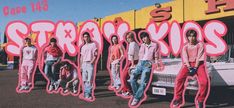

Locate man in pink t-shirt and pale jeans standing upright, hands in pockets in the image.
[80,32,98,100]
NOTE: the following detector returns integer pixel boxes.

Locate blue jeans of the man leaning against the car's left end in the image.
[130,60,152,100]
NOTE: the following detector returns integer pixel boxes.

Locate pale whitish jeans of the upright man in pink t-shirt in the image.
[82,62,94,96]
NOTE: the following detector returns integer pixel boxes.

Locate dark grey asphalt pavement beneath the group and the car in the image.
[0,70,234,108]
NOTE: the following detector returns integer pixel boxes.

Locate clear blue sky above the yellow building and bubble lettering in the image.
[0,0,171,43]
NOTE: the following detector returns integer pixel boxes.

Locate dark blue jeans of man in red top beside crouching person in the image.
[44,60,56,85]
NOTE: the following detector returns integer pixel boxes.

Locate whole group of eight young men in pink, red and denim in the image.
[17,30,209,108]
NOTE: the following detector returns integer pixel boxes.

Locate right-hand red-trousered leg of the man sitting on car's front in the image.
[197,64,210,103]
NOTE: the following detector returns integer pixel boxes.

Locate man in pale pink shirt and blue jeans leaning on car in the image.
[130,32,161,106]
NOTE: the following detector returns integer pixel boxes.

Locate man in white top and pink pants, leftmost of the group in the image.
[19,38,37,91]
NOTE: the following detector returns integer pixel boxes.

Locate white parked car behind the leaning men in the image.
[151,46,234,95]
